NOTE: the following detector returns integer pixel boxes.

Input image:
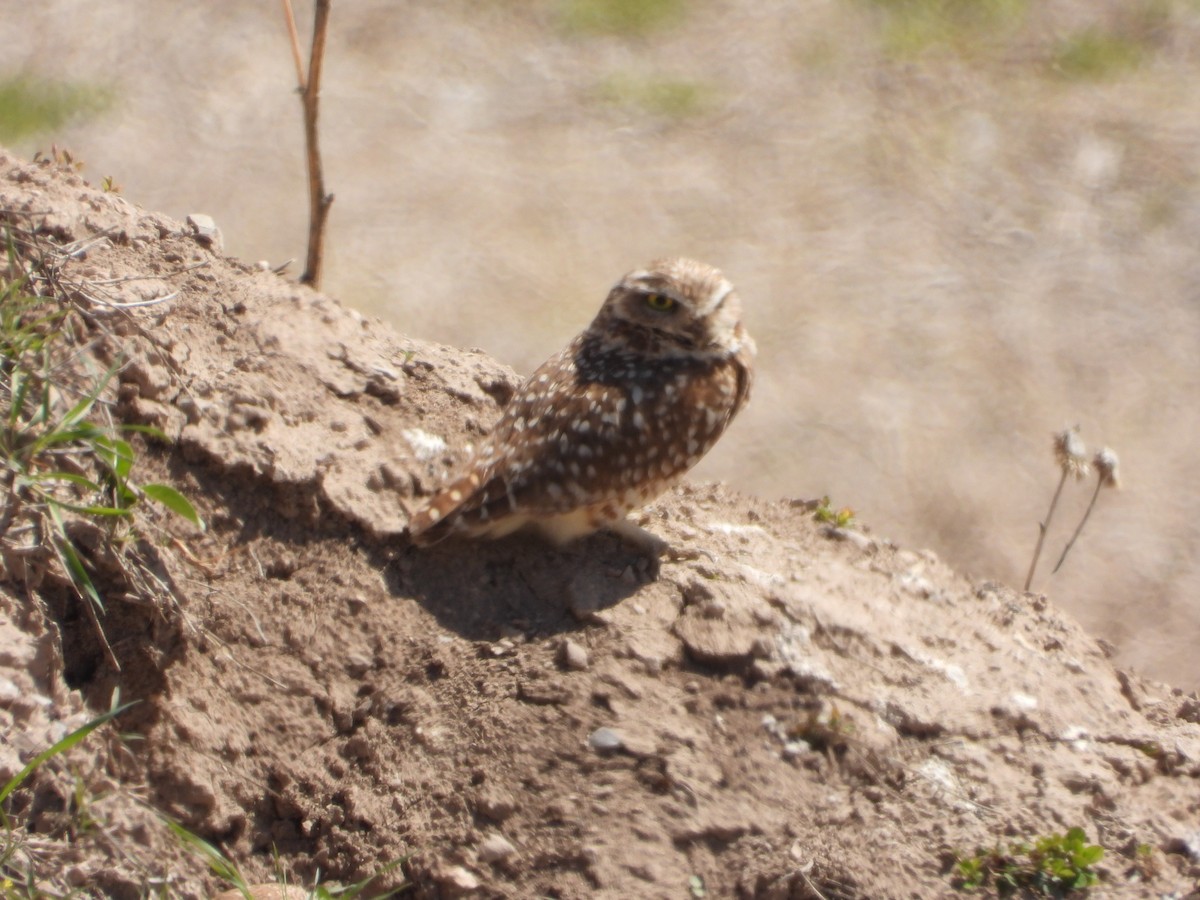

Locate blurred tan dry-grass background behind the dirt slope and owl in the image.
[0,0,1200,689]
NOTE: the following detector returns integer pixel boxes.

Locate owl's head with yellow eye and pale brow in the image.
[589,258,749,356]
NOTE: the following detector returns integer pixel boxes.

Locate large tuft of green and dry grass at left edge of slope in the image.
[0,219,204,668]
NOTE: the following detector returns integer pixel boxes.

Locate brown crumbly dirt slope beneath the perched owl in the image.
[0,155,1200,898]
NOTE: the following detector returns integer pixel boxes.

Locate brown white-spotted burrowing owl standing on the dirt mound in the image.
[409,259,755,550]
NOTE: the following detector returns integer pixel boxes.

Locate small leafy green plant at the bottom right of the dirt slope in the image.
[954,828,1104,896]
